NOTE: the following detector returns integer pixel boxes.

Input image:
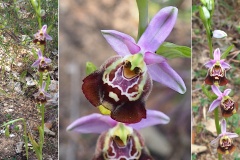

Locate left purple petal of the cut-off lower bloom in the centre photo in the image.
[67,113,117,133]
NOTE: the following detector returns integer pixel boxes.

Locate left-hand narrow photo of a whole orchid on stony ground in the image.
[0,0,58,160]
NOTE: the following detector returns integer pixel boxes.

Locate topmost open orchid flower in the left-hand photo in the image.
[33,25,52,45]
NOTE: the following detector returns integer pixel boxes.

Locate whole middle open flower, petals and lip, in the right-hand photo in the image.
[208,85,238,117]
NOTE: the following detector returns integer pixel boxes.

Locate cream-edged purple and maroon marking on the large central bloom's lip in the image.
[102,54,148,101]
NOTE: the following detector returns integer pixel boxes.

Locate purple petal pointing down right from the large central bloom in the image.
[147,62,186,94]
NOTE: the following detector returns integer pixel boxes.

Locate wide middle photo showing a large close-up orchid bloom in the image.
[59,0,192,160]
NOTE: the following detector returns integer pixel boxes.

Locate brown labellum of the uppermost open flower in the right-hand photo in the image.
[205,65,228,86]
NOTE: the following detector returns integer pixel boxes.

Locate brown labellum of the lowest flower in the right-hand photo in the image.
[217,136,236,154]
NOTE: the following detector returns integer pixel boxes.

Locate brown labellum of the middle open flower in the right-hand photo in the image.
[220,98,238,117]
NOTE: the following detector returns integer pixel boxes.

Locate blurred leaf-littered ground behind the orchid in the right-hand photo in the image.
[192,0,240,160]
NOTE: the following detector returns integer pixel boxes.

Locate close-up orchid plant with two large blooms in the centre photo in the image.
[67,0,191,160]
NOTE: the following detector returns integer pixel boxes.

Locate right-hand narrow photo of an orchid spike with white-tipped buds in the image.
[192,0,240,160]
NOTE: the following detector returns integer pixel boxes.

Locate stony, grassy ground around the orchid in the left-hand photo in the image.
[0,1,58,160]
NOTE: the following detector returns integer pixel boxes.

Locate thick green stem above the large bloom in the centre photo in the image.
[136,0,148,41]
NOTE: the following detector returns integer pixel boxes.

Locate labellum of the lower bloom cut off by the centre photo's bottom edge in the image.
[93,124,152,160]
